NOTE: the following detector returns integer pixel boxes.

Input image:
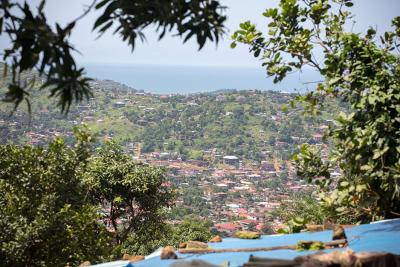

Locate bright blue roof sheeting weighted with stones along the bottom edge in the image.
[92,219,400,267]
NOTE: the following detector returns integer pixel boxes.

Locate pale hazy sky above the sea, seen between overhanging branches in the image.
[0,0,400,67]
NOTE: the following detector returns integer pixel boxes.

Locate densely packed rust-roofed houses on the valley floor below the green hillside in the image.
[134,149,336,236]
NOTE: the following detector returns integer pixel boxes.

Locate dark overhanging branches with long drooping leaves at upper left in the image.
[0,0,226,112]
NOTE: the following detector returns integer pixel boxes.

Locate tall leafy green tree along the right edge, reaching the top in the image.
[232,0,400,221]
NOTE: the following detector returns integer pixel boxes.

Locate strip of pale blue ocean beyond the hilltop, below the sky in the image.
[84,64,321,94]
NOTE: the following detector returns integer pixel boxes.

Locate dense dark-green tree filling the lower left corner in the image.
[0,129,112,266]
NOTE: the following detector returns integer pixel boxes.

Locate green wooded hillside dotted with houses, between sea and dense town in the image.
[0,72,346,164]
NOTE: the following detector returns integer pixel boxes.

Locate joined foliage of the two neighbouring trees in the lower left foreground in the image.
[0,129,172,266]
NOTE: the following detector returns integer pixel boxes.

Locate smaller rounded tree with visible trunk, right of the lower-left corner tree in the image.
[86,142,174,245]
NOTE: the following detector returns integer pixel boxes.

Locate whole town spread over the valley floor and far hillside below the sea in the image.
[0,77,345,236]
